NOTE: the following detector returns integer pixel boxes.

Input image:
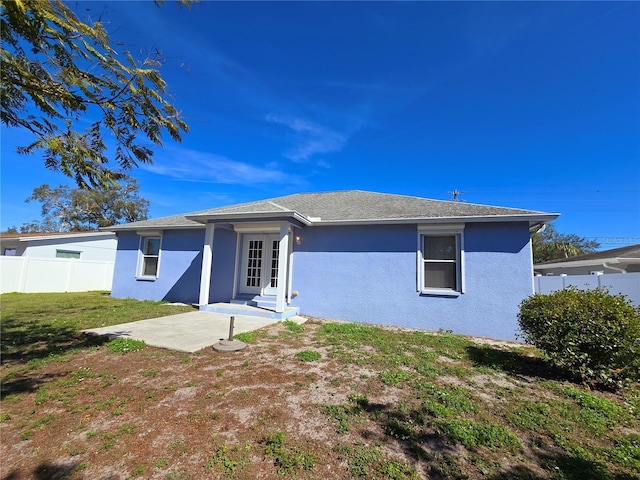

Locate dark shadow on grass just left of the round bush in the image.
[466,345,573,380]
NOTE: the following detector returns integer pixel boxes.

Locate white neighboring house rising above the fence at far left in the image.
[0,232,118,262]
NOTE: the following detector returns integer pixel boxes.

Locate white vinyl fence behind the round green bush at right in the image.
[534,272,640,305]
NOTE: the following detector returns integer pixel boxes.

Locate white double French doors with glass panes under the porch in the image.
[240,234,280,295]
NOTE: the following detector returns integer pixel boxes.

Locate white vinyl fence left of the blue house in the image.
[0,256,114,293]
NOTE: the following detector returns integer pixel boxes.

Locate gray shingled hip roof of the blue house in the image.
[107,190,558,231]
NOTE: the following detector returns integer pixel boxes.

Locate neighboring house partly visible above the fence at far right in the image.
[533,244,640,275]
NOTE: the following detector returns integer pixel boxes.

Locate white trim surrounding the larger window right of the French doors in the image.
[416,223,465,297]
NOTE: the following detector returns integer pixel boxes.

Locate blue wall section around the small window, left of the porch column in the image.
[111,228,204,303]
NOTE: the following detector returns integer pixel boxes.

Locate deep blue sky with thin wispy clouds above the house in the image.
[1,1,640,249]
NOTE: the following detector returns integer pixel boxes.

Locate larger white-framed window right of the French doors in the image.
[418,225,464,295]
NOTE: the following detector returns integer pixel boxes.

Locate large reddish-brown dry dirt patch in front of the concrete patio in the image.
[5,324,400,479]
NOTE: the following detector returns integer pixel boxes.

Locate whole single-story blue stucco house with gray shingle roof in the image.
[108,190,558,340]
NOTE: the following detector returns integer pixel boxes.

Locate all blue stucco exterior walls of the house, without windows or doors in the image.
[112,222,533,340]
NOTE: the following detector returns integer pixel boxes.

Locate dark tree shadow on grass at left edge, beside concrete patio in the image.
[0,317,109,365]
